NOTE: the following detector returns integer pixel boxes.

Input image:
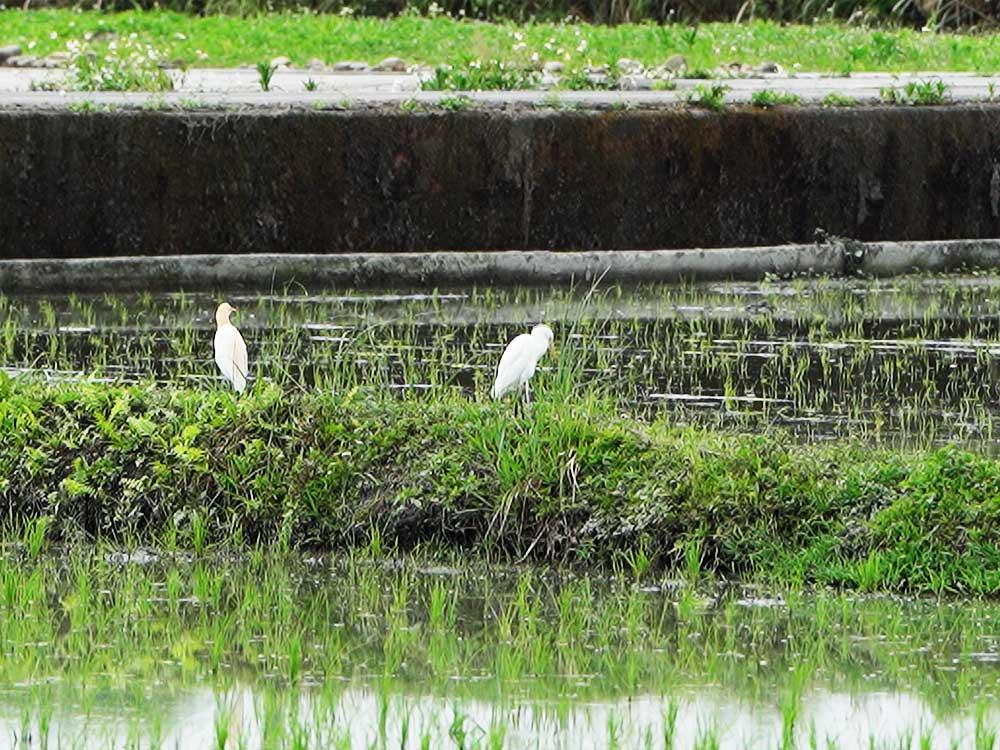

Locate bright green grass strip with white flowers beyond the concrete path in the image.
[0,10,1000,73]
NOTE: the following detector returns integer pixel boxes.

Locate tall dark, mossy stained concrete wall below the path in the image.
[0,105,1000,258]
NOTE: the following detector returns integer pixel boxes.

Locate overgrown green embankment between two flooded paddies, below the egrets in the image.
[0,378,1000,594]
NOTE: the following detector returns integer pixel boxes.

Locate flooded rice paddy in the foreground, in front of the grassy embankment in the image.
[0,552,1000,748]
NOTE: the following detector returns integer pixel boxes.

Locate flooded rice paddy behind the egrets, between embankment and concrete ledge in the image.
[0,276,1000,452]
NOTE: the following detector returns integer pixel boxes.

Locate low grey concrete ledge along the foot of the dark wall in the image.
[0,240,1000,293]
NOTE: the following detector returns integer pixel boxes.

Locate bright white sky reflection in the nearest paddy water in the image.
[0,685,1000,750]
